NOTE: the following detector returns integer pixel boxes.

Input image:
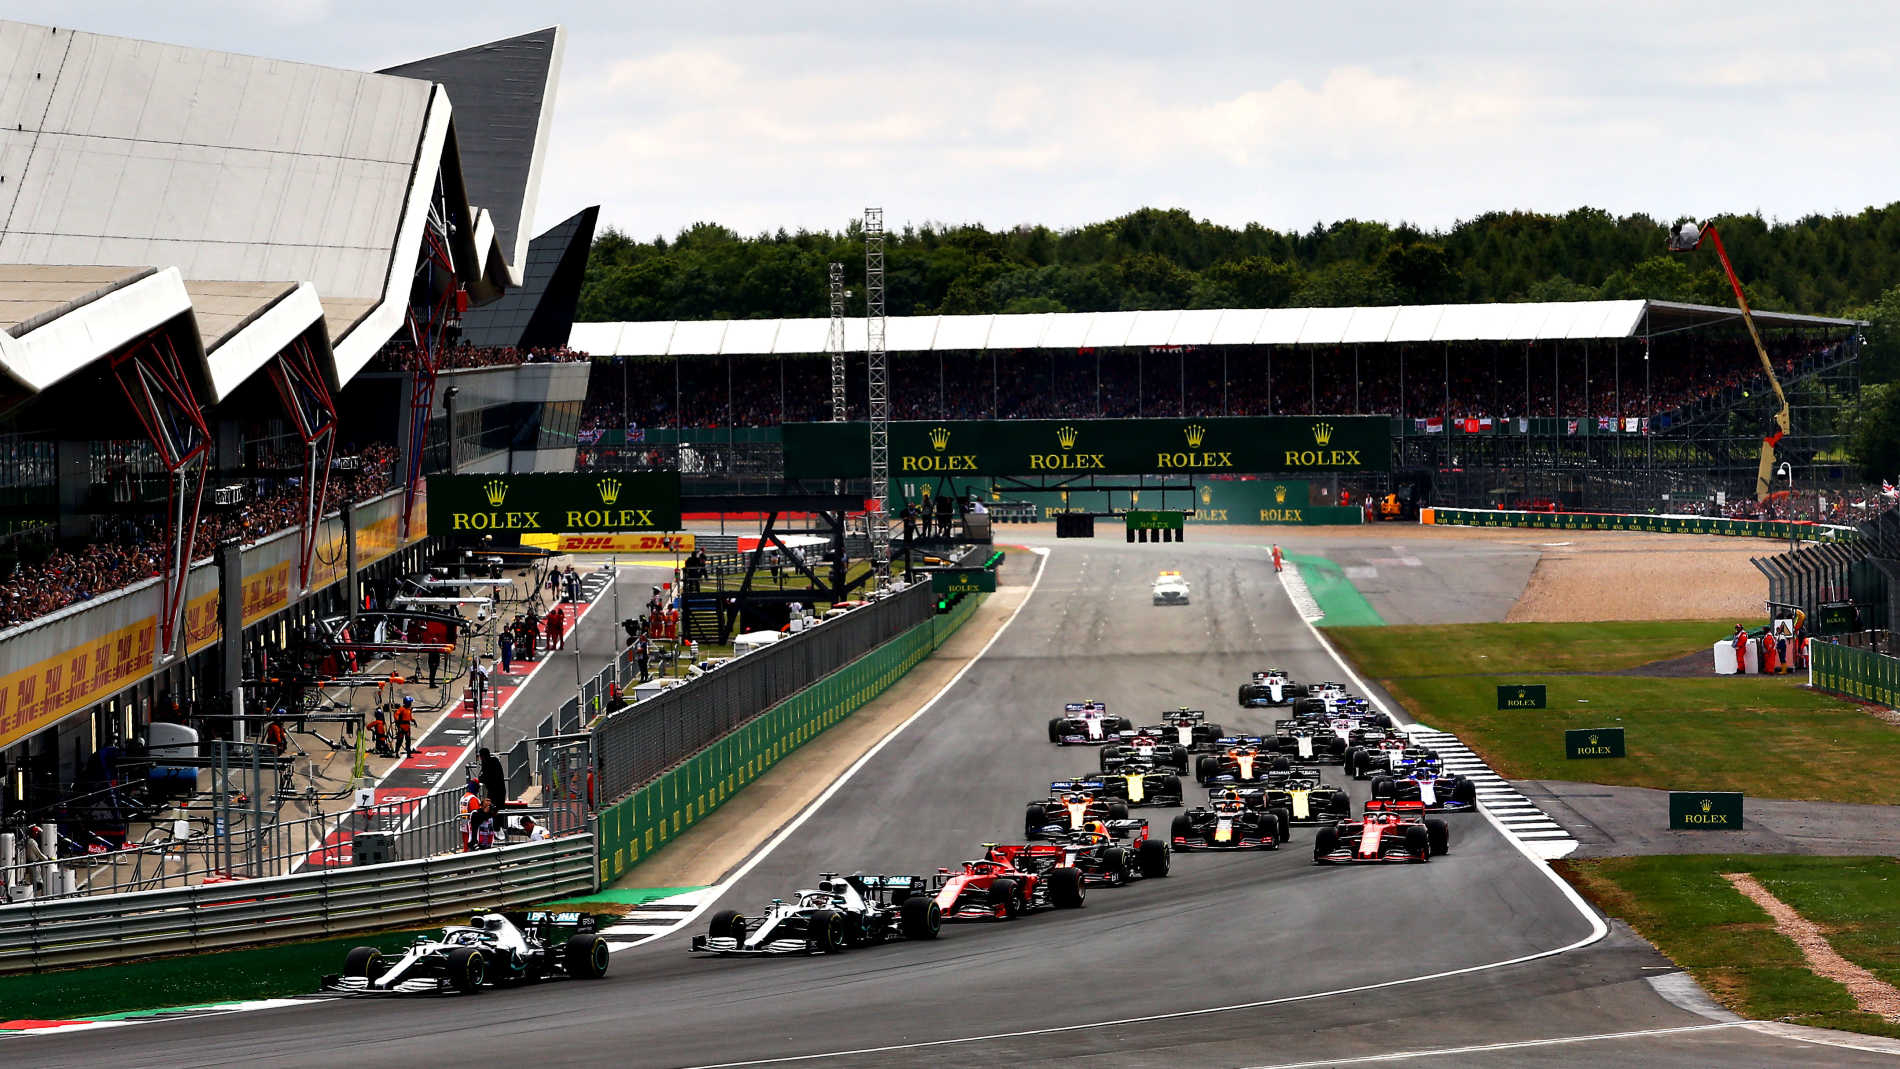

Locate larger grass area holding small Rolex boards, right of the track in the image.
[1326,623,1900,805]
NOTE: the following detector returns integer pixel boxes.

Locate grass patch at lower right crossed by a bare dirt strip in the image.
[1556,854,1900,1037]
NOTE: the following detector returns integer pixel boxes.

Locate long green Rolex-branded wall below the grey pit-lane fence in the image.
[595,596,982,885]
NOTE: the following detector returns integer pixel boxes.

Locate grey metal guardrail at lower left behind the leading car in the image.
[0,835,597,974]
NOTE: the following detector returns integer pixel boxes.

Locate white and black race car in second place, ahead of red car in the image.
[686,872,942,955]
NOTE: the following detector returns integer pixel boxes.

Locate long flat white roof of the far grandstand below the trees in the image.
[568,300,1856,357]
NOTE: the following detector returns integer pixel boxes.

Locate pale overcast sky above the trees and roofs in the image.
[26,0,1900,237]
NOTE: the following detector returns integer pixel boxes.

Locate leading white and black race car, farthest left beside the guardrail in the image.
[323,911,608,995]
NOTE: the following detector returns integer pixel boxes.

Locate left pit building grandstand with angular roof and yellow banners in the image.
[0,23,591,847]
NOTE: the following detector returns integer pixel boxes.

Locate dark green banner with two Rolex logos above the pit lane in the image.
[429,471,680,539]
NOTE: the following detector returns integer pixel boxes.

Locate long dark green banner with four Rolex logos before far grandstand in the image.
[785,416,1393,478]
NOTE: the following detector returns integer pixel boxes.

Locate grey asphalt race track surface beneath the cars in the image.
[23,541,1892,1067]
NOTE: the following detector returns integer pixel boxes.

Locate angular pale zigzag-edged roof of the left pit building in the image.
[0,21,562,403]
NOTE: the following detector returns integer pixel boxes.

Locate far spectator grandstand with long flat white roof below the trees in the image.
[570,300,1864,511]
